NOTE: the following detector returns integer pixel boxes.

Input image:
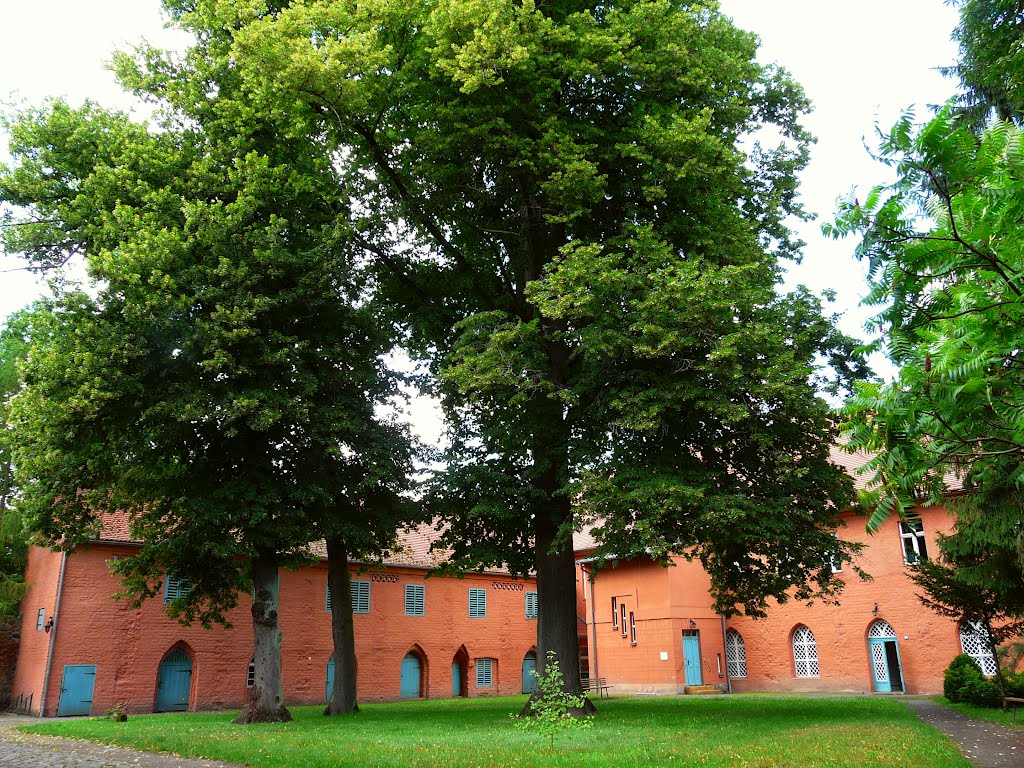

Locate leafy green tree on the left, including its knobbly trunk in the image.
[0,91,409,722]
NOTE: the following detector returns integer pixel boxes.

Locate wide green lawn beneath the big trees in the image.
[19,695,970,768]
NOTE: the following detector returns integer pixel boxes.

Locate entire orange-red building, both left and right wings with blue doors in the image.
[12,453,993,716]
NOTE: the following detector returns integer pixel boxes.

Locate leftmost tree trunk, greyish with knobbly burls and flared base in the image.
[234,557,292,725]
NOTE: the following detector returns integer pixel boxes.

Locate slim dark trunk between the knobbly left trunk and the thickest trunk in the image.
[324,537,359,715]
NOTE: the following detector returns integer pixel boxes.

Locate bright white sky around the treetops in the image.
[0,0,956,385]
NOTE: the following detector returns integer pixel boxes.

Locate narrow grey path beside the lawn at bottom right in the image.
[905,698,1024,768]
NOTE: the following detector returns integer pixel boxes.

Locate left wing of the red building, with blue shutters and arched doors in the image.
[11,525,537,716]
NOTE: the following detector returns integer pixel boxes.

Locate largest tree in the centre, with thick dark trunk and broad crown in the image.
[209,0,872,708]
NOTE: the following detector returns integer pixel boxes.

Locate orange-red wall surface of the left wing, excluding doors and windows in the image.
[14,545,537,716]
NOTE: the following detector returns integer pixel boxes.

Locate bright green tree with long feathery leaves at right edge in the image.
[830,109,1024,610]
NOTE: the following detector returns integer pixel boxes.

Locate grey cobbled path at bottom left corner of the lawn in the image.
[0,715,241,768]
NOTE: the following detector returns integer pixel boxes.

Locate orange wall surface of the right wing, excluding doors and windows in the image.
[584,508,974,693]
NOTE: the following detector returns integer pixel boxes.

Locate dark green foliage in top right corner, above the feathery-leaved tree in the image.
[942,0,1024,130]
